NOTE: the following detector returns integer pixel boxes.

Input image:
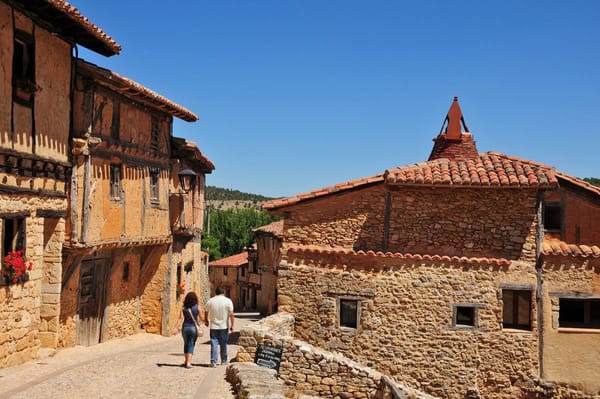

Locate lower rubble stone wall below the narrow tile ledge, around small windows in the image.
[279,255,538,398]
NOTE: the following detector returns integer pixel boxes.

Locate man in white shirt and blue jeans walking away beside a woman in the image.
[204,285,235,367]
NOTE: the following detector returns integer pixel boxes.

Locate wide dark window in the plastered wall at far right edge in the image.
[558,298,600,328]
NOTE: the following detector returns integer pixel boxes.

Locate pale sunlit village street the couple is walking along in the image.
[0,314,256,399]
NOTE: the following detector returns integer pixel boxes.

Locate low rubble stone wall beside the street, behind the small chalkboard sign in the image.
[234,313,432,399]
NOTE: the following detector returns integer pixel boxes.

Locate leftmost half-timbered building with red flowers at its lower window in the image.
[0,0,120,367]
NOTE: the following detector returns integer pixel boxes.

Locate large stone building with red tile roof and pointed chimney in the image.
[264,99,600,398]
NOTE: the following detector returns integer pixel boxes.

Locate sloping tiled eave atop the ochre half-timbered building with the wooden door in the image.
[77,59,198,122]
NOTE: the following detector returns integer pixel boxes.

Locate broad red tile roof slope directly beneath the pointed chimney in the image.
[384,152,558,188]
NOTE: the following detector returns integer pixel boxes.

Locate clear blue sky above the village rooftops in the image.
[76,0,600,197]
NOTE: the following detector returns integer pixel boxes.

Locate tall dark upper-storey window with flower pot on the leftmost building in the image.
[13,31,35,103]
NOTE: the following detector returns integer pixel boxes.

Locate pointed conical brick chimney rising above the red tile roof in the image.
[429,97,479,161]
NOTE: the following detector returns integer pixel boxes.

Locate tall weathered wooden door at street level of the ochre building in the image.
[77,259,109,346]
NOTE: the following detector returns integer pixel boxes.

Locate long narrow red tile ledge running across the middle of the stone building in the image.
[287,245,511,265]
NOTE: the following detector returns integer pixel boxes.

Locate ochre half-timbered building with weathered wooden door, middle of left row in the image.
[60,59,206,346]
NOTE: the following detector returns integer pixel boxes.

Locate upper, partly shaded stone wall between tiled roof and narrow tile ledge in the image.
[284,185,537,261]
